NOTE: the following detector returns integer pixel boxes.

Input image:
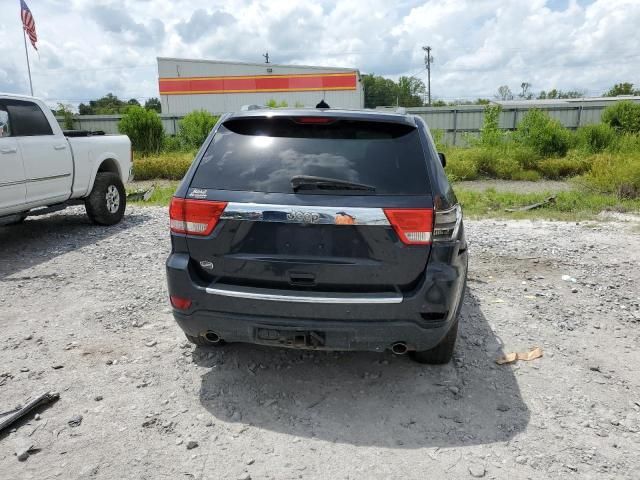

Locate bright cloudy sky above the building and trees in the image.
[0,0,640,106]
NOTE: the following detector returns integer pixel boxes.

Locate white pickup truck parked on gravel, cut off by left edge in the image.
[0,93,132,225]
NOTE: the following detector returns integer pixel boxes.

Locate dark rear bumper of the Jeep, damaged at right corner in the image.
[167,241,467,351]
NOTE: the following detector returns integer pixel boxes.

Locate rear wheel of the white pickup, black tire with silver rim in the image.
[84,172,127,225]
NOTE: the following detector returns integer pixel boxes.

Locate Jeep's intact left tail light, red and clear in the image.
[169,197,227,236]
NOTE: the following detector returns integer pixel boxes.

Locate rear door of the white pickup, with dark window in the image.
[5,100,73,207]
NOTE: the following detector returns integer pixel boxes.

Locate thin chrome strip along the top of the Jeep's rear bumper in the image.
[206,285,403,304]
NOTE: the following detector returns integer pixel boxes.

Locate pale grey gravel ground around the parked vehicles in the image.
[0,207,640,480]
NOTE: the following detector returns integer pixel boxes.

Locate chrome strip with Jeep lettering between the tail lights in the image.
[220,202,390,225]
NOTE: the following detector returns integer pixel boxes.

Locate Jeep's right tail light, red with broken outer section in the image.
[384,205,462,245]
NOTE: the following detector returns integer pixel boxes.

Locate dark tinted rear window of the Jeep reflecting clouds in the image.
[191,117,430,195]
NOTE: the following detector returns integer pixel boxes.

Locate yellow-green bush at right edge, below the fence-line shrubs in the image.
[580,152,640,199]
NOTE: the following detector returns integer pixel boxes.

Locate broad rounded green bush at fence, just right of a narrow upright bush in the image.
[514,109,571,157]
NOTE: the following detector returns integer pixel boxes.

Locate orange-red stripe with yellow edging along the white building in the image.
[159,72,358,95]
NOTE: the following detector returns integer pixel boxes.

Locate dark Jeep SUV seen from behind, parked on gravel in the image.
[167,109,467,363]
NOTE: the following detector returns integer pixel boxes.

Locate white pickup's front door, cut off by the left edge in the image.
[0,103,27,214]
